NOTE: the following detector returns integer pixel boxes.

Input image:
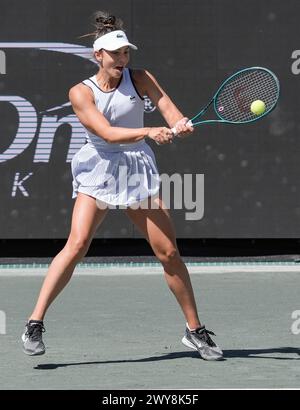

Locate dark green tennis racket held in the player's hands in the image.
[172,67,280,135]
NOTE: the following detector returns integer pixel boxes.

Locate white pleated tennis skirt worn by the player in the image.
[71,141,160,207]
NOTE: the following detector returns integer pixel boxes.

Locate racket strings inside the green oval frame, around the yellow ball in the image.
[215,69,279,122]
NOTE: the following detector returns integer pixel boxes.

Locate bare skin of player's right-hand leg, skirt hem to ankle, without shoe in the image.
[126,198,200,329]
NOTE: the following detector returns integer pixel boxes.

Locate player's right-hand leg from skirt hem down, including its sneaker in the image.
[126,198,223,360]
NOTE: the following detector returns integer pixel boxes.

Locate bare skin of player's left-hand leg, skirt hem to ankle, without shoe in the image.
[30,193,107,320]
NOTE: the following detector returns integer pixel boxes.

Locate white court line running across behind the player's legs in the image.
[0,263,300,277]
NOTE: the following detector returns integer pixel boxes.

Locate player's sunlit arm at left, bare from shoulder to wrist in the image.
[69,84,150,143]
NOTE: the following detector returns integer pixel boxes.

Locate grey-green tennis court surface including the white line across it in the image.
[0,262,300,390]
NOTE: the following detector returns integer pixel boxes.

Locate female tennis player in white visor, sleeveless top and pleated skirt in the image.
[22,12,223,360]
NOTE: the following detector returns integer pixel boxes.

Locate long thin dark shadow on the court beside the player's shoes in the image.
[34,347,300,370]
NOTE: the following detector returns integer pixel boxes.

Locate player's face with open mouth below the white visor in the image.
[99,46,129,78]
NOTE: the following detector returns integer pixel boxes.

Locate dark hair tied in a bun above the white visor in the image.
[80,11,123,40]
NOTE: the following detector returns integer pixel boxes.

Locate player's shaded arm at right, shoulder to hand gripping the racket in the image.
[133,70,193,133]
